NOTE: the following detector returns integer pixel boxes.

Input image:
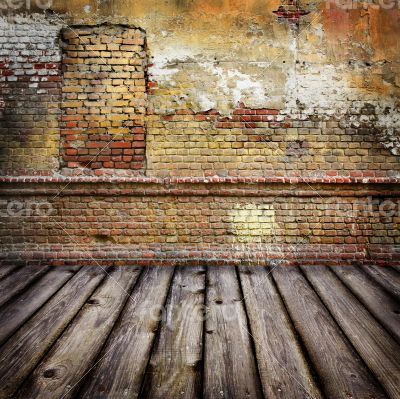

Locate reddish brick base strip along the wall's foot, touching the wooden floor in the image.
[0,244,400,266]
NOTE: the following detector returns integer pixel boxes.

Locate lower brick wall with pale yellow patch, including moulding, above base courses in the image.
[0,179,400,266]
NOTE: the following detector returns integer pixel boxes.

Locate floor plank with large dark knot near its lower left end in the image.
[15,267,141,399]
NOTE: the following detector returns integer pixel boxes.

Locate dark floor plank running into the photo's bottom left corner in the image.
[0,267,104,398]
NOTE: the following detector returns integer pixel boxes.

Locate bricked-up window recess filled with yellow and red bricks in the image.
[61,25,147,174]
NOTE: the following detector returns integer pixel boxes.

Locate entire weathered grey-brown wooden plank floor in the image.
[0,266,400,399]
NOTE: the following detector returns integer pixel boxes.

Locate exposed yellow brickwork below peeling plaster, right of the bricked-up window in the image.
[147,104,400,177]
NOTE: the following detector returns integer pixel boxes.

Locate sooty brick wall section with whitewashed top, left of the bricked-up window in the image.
[0,17,61,175]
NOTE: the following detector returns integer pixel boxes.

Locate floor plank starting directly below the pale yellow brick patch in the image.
[239,267,321,399]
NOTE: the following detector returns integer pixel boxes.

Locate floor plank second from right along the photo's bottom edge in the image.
[272,267,386,399]
